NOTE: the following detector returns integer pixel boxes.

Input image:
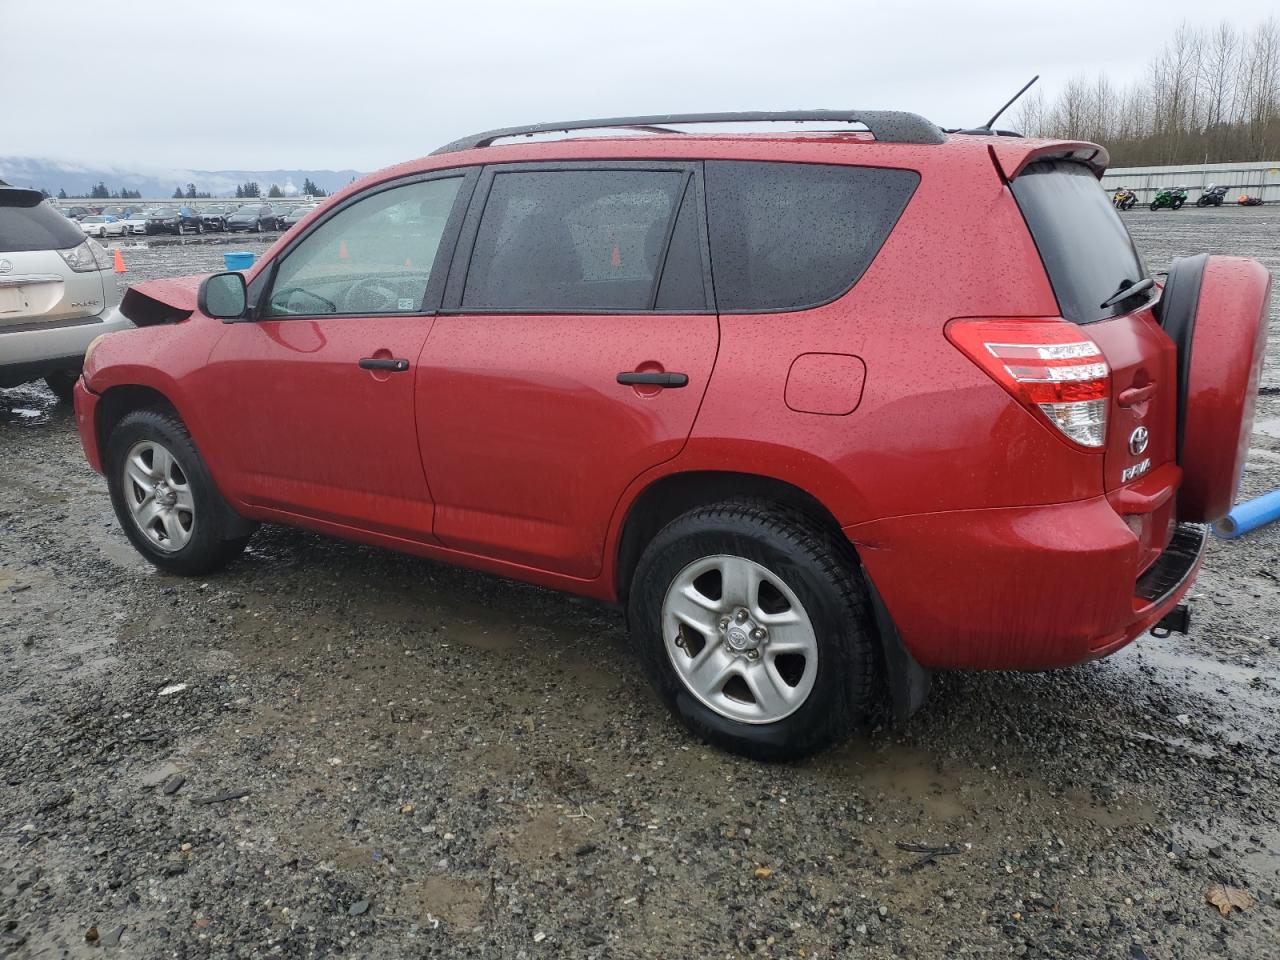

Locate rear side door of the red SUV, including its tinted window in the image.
[417,163,718,577]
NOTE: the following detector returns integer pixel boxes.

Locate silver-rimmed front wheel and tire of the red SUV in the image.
[105,410,255,576]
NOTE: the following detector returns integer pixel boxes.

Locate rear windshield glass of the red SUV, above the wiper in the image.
[1012,160,1146,324]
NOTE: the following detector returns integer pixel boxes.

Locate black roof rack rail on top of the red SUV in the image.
[431,110,946,156]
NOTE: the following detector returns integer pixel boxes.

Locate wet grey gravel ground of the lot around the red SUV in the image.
[0,207,1280,960]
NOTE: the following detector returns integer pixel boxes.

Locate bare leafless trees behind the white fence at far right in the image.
[1015,17,1280,166]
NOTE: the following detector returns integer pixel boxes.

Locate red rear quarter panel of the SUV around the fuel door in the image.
[672,142,1102,525]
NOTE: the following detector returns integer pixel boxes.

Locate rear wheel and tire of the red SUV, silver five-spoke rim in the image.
[627,500,881,760]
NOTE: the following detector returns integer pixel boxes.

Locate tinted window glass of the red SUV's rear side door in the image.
[462,170,703,311]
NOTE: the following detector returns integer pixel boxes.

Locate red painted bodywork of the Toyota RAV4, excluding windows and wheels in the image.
[76,126,1267,686]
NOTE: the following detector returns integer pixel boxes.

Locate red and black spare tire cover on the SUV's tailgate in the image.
[1161,256,1271,524]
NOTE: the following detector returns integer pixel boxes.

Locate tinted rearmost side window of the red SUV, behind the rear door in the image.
[705,160,920,312]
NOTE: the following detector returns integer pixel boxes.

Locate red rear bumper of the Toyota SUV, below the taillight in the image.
[845,497,1206,669]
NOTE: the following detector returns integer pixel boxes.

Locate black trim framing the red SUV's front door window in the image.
[246,164,480,323]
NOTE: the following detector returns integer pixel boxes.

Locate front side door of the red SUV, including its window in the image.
[204,173,465,540]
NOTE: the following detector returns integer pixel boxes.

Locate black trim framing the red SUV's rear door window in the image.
[438,160,716,316]
